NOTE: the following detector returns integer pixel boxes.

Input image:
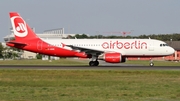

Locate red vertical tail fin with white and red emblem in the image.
[9,12,37,41]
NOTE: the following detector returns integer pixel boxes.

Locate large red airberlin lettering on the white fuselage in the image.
[102,41,147,49]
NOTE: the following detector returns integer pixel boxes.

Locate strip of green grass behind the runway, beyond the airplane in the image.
[0,59,180,66]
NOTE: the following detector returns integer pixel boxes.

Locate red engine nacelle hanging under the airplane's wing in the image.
[98,53,126,63]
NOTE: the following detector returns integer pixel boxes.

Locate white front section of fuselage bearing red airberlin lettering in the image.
[43,39,174,56]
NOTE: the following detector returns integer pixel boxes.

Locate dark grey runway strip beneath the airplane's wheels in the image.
[0,65,180,70]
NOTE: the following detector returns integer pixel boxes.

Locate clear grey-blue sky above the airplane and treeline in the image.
[0,0,180,41]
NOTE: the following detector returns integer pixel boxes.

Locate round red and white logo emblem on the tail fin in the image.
[11,16,27,37]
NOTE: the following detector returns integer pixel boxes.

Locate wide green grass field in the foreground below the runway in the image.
[0,69,180,101]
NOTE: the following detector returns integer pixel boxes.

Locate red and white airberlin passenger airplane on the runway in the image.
[6,12,175,66]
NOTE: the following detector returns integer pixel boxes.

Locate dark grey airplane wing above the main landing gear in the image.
[65,45,104,55]
